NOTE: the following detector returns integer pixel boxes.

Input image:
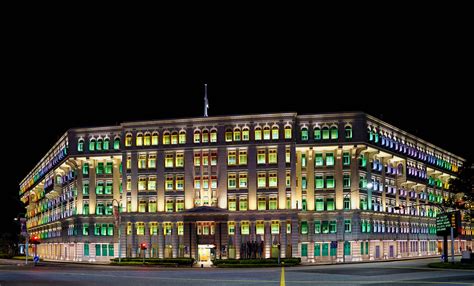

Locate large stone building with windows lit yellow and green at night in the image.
[20,113,473,263]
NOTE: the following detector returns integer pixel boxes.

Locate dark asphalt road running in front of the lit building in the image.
[0,259,474,286]
